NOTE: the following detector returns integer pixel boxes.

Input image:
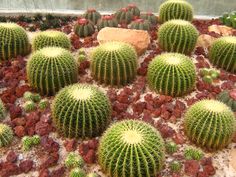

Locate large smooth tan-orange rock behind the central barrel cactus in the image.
[97,27,150,55]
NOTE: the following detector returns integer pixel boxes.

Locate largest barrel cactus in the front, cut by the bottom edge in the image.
[98,120,164,177]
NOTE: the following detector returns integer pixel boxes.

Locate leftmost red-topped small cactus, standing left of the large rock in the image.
[74,18,95,37]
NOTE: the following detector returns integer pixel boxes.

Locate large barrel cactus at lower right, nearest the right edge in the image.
[184,100,236,150]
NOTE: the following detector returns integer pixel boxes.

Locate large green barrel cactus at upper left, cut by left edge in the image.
[0,23,30,61]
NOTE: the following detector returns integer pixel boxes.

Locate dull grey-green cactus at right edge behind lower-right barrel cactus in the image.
[216,89,236,112]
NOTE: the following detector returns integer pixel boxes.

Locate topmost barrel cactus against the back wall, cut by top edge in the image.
[159,0,193,23]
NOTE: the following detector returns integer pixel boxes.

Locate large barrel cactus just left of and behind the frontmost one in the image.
[52,84,111,138]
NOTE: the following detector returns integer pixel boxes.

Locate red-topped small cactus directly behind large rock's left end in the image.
[97,15,118,31]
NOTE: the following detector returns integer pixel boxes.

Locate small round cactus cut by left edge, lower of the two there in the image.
[0,123,13,148]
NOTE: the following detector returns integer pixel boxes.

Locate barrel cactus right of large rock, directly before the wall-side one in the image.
[158,20,198,54]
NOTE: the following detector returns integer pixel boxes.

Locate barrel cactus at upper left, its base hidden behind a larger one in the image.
[32,30,71,51]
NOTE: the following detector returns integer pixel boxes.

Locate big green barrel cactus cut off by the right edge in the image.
[209,36,236,73]
